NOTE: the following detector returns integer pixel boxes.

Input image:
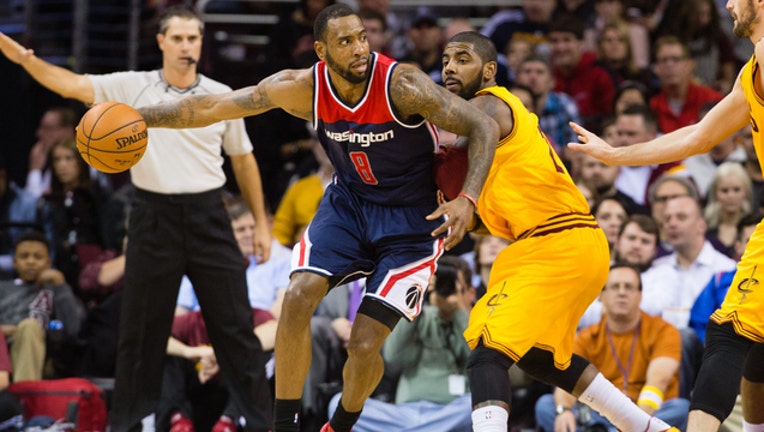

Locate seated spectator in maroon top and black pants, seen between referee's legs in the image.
[156,309,277,432]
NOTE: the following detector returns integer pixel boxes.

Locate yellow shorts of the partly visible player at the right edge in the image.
[711,228,764,343]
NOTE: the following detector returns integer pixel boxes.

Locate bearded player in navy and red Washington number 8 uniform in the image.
[140,4,499,432]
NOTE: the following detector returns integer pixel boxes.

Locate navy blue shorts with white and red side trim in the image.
[292,183,444,321]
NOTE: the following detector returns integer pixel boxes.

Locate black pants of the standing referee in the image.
[110,190,272,432]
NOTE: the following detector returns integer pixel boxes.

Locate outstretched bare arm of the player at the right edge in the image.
[568,69,750,166]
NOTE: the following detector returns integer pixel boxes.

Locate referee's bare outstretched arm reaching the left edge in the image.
[0,33,95,104]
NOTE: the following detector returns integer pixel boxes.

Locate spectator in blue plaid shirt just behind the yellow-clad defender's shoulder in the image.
[516,56,580,154]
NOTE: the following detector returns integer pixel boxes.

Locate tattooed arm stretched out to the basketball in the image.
[138,69,313,129]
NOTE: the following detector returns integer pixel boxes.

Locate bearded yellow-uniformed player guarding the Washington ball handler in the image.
[430,32,676,432]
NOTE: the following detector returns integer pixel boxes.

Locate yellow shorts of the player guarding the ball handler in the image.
[464,224,610,370]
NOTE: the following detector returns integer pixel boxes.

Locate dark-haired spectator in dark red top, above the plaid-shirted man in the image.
[549,16,615,130]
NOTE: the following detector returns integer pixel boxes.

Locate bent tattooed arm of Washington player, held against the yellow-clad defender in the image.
[390,65,499,250]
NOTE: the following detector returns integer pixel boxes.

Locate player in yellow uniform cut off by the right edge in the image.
[569,0,764,432]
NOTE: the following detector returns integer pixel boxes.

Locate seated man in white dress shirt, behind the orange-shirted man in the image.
[642,196,736,398]
